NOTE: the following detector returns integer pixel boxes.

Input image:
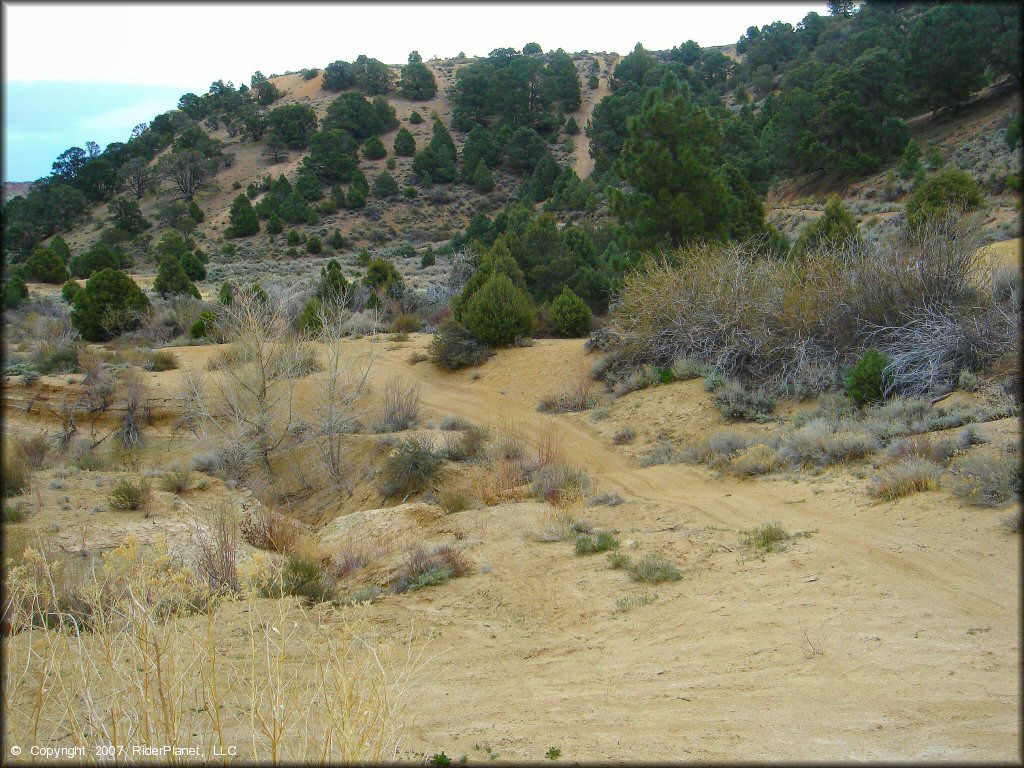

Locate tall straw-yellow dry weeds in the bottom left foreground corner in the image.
[3,540,415,765]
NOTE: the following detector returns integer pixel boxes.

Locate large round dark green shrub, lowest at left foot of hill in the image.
[71,268,149,341]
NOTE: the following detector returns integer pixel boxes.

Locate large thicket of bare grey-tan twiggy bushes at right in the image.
[607,212,1020,396]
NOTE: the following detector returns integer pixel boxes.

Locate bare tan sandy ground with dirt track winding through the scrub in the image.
[6,335,1020,761]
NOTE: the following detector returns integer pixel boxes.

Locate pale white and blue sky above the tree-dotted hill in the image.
[3,2,827,180]
